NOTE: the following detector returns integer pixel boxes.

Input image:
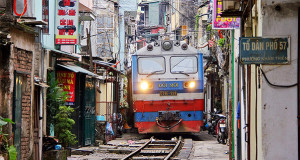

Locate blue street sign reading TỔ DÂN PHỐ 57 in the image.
[239,37,290,64]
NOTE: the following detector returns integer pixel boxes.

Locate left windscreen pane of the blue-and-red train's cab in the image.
[138,57,166,75]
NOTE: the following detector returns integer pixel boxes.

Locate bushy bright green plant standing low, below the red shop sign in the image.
[54,106,77,147]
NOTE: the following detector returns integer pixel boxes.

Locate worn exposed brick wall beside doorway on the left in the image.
[13,47,33,160]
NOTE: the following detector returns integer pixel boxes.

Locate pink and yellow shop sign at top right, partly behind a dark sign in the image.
[212,0,240,29]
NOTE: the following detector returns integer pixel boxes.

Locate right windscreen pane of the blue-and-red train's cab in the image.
[170,56,198,74]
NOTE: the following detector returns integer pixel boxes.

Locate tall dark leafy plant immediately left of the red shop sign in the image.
[47,73,68,131]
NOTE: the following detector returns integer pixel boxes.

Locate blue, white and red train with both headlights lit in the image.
[132,40,204,134]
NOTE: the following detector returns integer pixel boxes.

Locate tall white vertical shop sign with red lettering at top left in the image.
[55,0,79,44]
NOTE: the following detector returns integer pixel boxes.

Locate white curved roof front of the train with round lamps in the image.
[134,40,198,56]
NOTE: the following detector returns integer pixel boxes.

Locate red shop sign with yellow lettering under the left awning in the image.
[56,71,76,105]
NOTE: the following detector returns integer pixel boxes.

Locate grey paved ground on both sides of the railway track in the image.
[68,131,229,160]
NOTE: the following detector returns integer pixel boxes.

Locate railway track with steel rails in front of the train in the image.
[122,136,182,160]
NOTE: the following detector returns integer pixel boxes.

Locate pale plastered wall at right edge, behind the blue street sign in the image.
[259,0,300,160]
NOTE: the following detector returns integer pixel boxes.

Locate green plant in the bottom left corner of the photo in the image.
[0,116,17,160]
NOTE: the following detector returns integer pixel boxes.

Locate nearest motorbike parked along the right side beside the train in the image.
[216,115,228,144]
